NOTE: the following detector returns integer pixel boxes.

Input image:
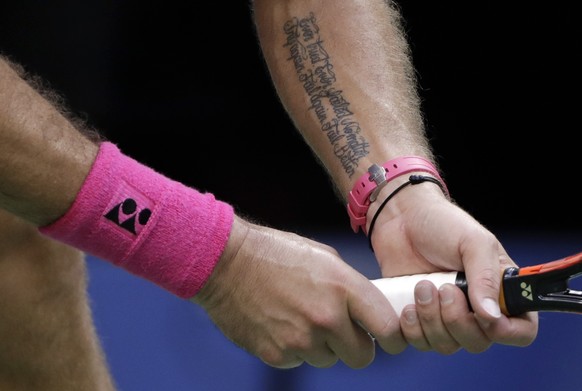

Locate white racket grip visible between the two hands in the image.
[371,272,458,316]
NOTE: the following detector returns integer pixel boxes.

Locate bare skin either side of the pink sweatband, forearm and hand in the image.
[0,53,407,368]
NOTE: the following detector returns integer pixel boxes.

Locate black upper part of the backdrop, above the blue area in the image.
[0,0,582,236]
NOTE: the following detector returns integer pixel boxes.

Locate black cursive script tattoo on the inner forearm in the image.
[283,13,370,177]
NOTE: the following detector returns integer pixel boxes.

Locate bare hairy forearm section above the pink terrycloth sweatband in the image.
[0,58,97,225]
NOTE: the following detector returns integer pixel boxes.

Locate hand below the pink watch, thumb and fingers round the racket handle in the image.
[368,179,538,354]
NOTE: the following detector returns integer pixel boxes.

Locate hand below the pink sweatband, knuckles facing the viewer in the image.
[193,218,407,368]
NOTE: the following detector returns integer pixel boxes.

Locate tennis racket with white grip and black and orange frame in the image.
[372,252,582,316]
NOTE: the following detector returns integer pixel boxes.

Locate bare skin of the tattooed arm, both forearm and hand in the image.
[254,0,538,354]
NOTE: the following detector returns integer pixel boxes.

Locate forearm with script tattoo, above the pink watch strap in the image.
[254,0,432,197]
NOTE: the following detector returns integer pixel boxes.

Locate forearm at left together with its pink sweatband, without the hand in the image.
[0,56,233,298]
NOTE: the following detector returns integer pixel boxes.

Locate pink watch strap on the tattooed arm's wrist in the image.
[347,156,446,233]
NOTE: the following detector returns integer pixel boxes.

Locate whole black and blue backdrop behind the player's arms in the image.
[0,0,582,391]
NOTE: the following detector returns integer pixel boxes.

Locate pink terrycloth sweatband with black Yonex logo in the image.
[40,142,234,298]
